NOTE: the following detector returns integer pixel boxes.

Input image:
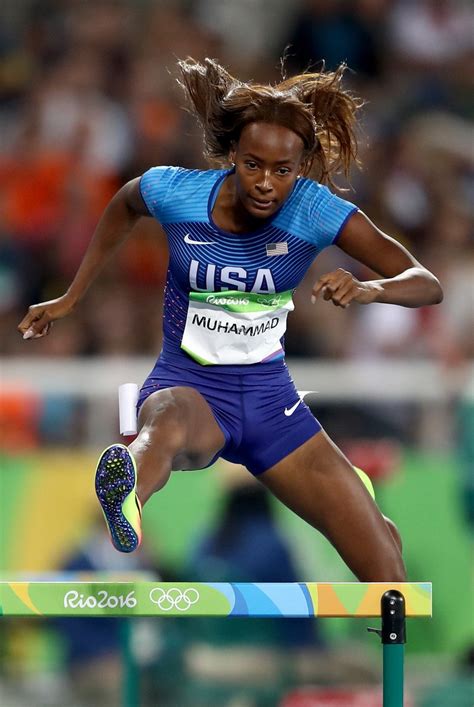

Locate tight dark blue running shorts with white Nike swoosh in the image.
[137,359,321,476]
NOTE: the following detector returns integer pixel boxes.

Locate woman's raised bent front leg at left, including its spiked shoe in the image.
[95,386,225,552]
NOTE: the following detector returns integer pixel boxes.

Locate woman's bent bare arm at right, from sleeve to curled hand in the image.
[312,211,443,307]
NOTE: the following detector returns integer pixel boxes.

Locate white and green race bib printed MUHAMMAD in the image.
[181,290,294,366]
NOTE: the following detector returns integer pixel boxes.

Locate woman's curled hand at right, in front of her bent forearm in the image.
[311,268,381,308]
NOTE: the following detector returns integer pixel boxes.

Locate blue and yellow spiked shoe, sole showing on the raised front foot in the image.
[95,444,142,552]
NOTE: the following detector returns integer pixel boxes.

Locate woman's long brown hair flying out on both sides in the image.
[178,58,362,186]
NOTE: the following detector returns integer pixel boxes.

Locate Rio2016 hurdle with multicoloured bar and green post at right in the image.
[0,581,432,707]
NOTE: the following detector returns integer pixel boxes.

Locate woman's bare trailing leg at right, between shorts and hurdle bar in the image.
[258,430,406,582]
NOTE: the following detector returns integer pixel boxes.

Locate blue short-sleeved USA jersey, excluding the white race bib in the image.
[140,167,357,374]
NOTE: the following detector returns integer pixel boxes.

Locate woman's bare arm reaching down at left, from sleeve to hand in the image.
[18,177,150,339]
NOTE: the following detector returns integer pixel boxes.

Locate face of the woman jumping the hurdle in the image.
[230,123,304,219]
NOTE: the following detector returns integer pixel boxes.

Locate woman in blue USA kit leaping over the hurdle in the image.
[19,59,442,582]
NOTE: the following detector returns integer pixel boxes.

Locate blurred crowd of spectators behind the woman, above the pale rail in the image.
[0,0,474,364]
